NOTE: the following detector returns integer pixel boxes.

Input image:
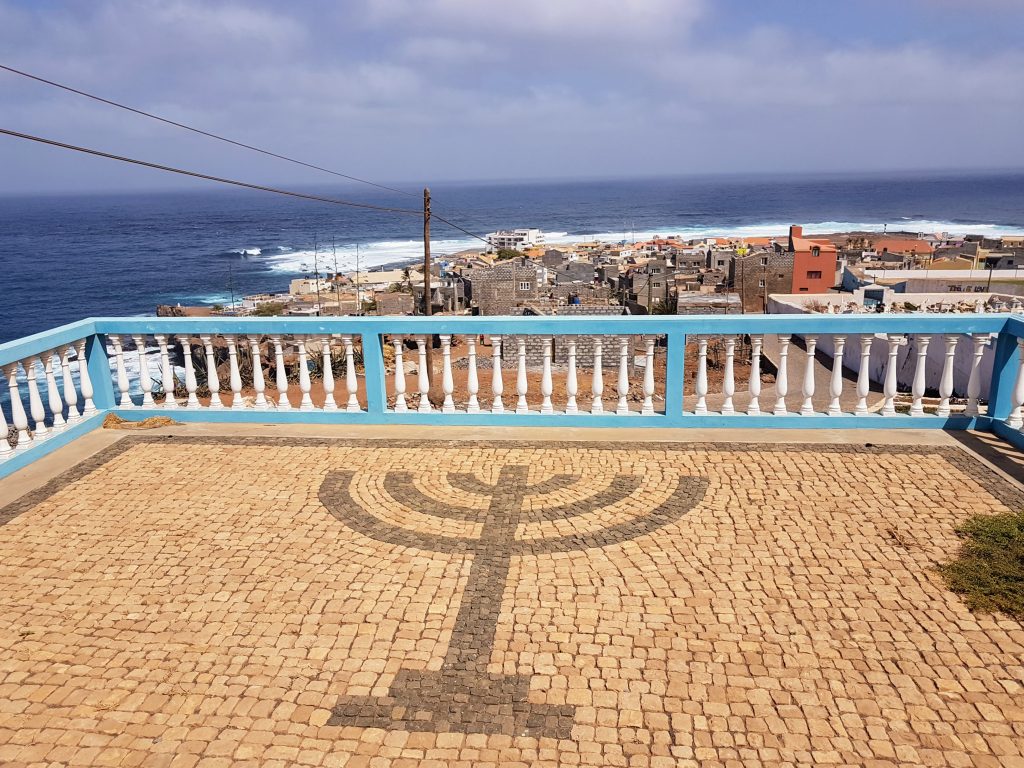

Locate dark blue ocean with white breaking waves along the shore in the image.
[0,173,1024,341]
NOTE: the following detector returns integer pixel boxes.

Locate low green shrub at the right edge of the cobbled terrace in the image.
[938,512,1024,620]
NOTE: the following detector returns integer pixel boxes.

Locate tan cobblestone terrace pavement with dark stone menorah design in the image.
[0,436,1024,768]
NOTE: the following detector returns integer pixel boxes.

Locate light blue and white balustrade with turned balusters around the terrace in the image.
[0,315,1024,473]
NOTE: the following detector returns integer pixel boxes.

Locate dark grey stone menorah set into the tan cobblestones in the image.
[319,464,708,738]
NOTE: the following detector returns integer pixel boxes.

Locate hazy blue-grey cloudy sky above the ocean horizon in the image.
[0,0,1024,194]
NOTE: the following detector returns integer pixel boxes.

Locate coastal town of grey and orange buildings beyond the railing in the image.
[158,225,1024,316]
